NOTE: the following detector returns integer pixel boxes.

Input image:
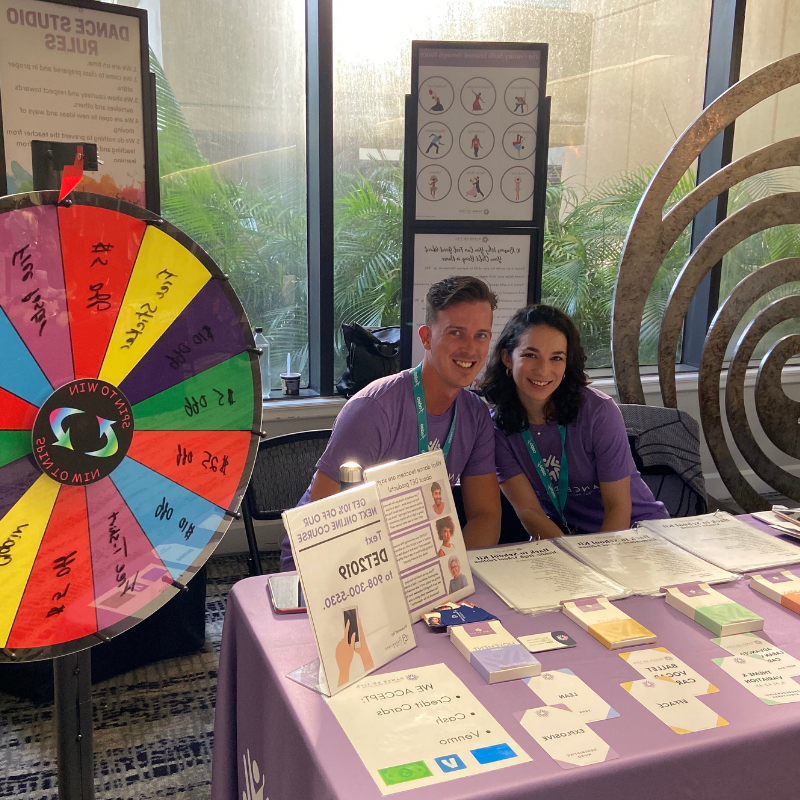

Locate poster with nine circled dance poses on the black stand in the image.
[412,43,545,222]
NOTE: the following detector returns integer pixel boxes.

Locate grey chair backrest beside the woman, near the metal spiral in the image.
[619,404,708,517]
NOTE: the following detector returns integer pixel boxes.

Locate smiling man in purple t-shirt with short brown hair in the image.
[281,276,500,570]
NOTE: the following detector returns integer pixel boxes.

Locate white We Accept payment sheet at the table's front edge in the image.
[328,664,532,795]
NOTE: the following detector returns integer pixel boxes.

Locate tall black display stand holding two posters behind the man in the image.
[400,42,550,369]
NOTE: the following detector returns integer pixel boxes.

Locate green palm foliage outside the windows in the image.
[151,45,800,376]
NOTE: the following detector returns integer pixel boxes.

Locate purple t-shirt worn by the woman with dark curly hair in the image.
[494,386,669,533]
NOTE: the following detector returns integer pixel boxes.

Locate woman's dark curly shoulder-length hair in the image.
[481,304,589,433]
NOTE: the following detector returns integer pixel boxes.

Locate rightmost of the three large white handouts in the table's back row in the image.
[641,511,800,572]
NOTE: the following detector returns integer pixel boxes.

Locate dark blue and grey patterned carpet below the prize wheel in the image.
[0,553,279,800]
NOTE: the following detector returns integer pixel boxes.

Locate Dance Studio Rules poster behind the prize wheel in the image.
[0,0,148,206]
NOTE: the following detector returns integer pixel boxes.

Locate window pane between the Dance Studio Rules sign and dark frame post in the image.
[141,0,308,388]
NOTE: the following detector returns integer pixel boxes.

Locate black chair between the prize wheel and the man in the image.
[242,429,331,575]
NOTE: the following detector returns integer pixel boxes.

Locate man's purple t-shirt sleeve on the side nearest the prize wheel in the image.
[317,397,391,481]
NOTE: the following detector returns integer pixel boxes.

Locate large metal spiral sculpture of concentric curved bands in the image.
[611,54,800,511]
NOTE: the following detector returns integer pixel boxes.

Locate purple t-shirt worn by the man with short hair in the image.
[281,370,495,571]
